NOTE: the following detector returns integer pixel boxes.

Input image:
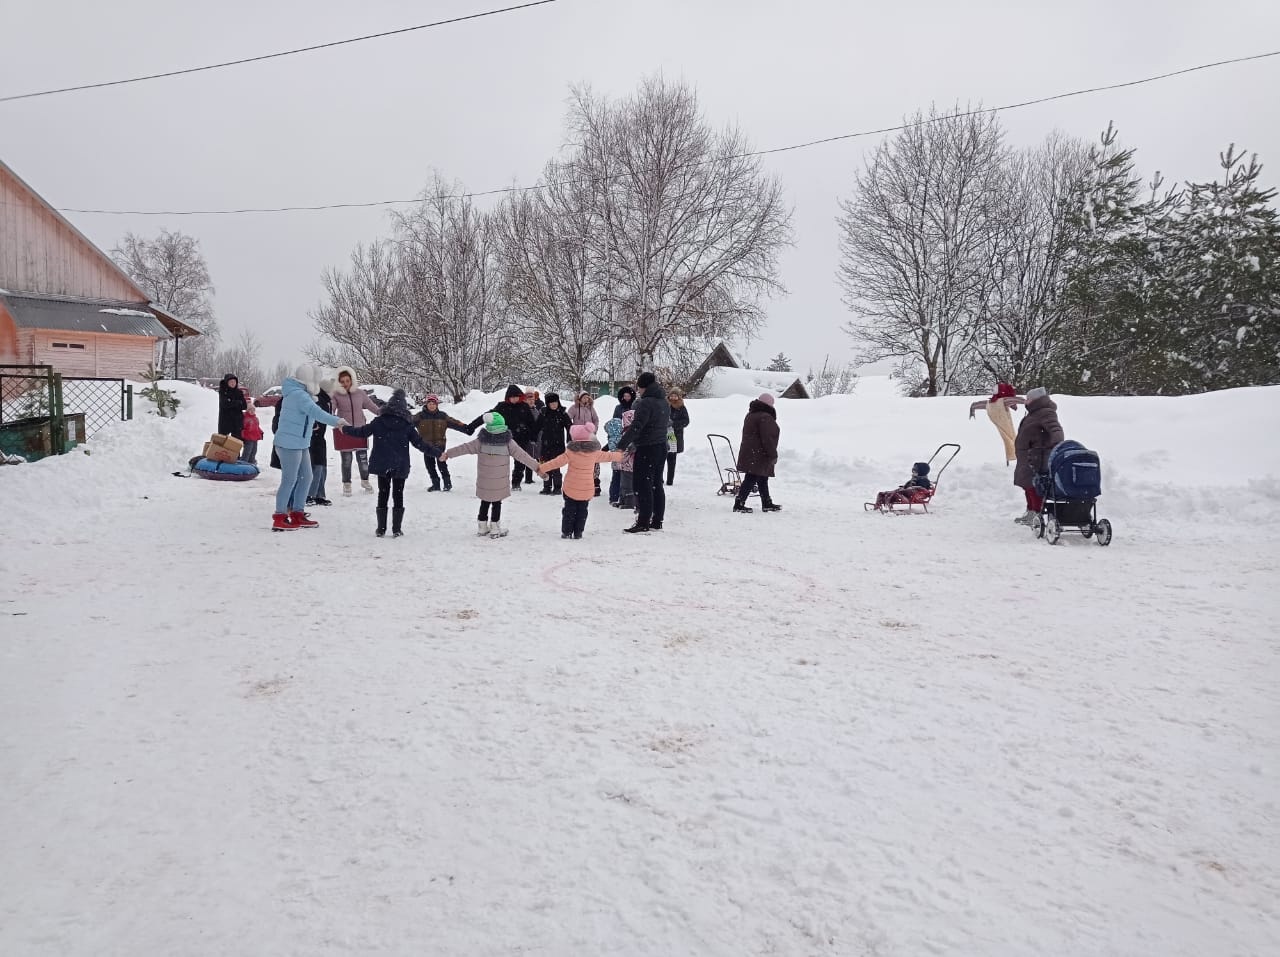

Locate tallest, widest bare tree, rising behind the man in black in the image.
[564,77,791,366]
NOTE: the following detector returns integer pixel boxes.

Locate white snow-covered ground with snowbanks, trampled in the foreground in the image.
[0,379,1280,957]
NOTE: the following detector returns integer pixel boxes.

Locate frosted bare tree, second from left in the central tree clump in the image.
[388,177,516,402]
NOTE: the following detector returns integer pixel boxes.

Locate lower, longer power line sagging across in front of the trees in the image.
[49,47,1280,216]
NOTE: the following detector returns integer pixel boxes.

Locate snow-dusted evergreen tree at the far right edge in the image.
[1162,145,1280,392]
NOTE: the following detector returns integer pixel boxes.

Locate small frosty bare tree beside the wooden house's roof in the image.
[111,229,221,377]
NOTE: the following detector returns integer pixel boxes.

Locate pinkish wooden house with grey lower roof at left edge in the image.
[0,162,200,379]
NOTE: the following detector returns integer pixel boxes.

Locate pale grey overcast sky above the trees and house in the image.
[0,0,1280,371]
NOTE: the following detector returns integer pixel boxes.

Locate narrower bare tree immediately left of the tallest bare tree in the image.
[497,161,614,389]
